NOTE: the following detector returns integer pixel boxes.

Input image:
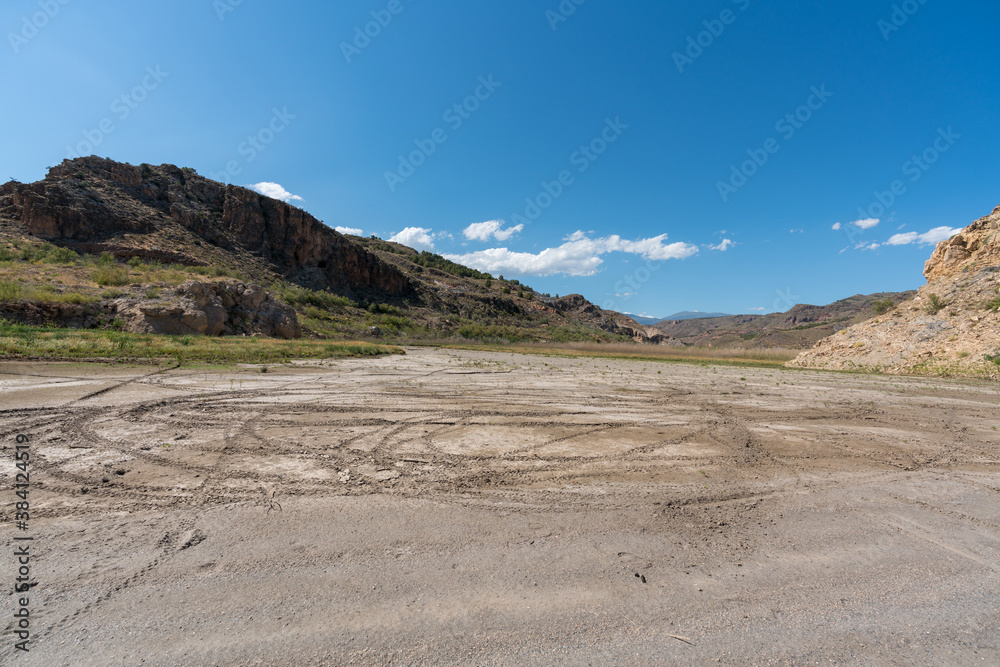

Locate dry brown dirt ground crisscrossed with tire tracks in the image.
[0,349,1000,666]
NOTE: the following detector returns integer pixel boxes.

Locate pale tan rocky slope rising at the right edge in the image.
[789,207,1000,379]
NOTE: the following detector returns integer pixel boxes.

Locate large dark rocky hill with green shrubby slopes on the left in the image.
[0,157,667,343]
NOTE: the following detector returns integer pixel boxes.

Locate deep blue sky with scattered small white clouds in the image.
[0,0,1000,315]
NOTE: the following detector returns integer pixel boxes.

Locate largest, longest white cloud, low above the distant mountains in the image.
[445,231,698,276]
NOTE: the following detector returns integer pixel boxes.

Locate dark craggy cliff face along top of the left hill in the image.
[0,157,411,296]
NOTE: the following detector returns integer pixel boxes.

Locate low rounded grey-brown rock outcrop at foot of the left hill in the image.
[115,280,302,338]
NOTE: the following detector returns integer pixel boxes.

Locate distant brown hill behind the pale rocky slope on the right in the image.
[655,292,916,349]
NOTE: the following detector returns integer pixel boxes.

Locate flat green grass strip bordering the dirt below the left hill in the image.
[0,322,403,365]
